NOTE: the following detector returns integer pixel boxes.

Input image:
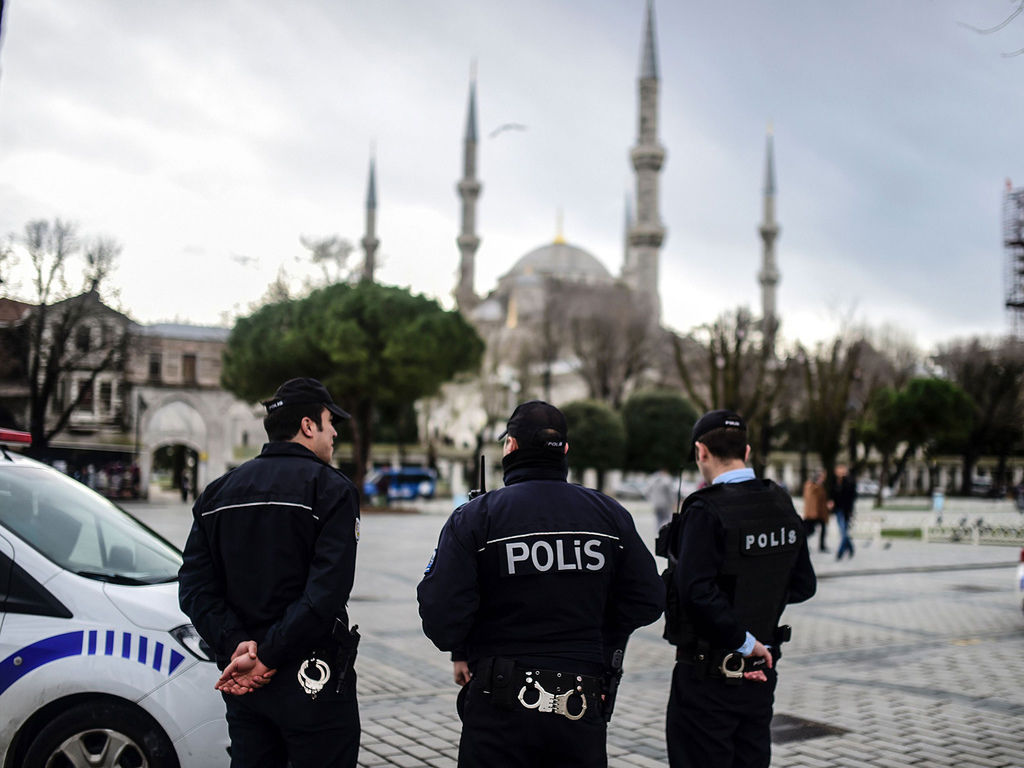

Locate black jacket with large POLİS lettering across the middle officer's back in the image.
[418,455,665,672]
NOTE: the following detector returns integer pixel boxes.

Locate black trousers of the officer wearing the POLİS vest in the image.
[666,662,778,768]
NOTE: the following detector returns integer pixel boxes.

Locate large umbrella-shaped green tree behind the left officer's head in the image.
[221,283,483,499]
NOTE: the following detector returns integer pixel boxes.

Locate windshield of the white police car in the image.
[0,465,181,585]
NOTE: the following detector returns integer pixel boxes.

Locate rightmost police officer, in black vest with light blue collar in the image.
[659,411,816,768]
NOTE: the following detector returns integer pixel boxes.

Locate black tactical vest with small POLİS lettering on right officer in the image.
[659,479,805,647]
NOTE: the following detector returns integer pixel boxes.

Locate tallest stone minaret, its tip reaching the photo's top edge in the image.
[623,0,665,324]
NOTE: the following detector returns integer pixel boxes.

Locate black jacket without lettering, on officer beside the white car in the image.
[178,442,359,669]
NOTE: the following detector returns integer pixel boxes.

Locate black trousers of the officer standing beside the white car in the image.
[223,663,359,768]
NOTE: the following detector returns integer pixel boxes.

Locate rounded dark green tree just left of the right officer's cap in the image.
[623,390,698,474]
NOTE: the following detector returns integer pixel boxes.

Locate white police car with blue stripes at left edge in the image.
[0,430,228,768]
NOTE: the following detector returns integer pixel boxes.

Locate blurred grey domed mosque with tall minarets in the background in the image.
[361,0,779,456]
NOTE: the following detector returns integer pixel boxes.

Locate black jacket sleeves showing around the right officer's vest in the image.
[674,480,817,650]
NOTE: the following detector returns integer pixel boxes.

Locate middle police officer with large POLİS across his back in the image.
[418,400,665,768]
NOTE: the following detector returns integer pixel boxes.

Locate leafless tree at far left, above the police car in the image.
[20,219,131,449]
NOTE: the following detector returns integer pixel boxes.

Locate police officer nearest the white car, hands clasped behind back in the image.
[179,379,359,768]
